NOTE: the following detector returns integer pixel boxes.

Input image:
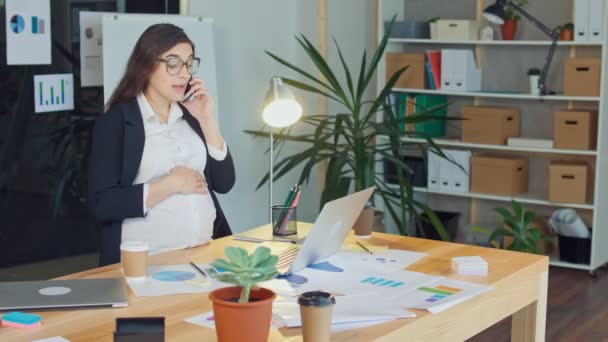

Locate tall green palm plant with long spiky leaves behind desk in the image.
[246,18,450,240]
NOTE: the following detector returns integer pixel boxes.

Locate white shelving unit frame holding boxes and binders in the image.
[377,0,608,272]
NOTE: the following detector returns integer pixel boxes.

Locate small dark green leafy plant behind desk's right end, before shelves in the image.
[472,201,554,254]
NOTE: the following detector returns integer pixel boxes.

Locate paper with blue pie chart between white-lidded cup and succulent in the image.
[127,264,231,297]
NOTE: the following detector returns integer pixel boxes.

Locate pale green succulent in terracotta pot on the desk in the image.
[209,247,278,341]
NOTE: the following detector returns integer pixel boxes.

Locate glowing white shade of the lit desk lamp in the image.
[262,77,302,128]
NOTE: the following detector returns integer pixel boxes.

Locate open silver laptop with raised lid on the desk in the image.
[271,187,376,275]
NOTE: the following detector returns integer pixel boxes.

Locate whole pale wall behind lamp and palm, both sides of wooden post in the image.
[188,0,375,231]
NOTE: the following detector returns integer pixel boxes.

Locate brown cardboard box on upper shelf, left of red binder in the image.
[386,53,425,89]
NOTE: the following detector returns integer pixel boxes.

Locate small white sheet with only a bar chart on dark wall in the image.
[34,74,74,113]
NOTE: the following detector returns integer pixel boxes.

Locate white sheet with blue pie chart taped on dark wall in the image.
[5,0,51,65]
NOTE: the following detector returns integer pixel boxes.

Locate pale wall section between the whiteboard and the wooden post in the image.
[188,0,318,232]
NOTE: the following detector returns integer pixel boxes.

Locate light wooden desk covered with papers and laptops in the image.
[0,223,549,342]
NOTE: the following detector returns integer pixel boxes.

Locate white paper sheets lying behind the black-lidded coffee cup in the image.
[272,294,416,327]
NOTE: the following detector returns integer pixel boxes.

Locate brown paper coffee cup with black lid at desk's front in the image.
[298,291,336,342]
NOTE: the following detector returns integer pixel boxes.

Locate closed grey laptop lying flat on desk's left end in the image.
[0,278,129,310]
